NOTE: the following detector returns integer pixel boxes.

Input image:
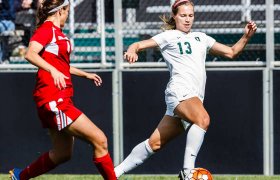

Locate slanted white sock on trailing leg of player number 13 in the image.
[115,139,154,178]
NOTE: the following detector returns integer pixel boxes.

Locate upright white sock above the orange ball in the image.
[183,124,206,171]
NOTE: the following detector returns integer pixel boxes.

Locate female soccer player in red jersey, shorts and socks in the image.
[10,0,116,180]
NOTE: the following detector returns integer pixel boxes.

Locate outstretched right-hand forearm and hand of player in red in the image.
[70,66,102,86]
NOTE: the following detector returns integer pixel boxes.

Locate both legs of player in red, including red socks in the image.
[20,114,116,180]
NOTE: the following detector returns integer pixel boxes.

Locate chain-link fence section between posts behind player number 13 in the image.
[123,0,266,62]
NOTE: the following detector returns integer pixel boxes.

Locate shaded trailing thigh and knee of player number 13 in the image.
[149,115,185,147]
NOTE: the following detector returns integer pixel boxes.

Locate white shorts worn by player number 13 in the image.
[165,86,204,116]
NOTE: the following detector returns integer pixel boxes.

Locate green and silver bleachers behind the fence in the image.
[2,0,280,64]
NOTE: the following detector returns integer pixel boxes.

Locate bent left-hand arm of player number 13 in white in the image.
[124,39,158,63]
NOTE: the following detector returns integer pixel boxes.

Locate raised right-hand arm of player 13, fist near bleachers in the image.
[209,21,257,59]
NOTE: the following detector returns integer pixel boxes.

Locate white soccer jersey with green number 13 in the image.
[152,30,216,99]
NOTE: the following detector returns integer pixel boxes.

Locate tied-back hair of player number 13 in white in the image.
[160,0,194,30]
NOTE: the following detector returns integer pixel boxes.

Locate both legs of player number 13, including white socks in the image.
[115,97,210,177]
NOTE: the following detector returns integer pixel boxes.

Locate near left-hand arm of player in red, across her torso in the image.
[25,41,69,89]
